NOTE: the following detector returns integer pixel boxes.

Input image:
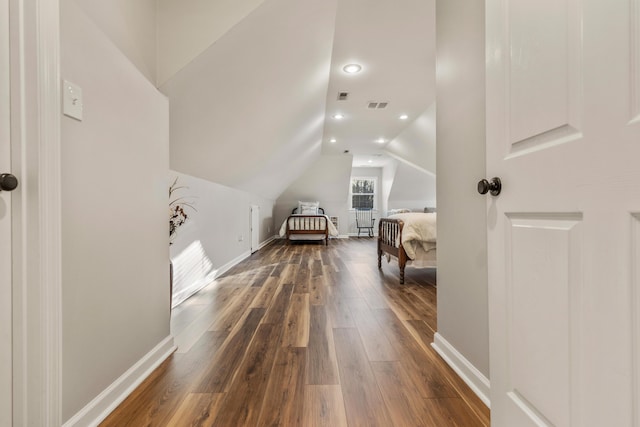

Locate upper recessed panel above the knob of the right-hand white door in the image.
[505,0,582,156]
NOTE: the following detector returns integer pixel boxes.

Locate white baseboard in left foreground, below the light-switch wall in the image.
[63,335,176,427]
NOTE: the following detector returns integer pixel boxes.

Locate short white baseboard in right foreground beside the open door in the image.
[431,332,491,408]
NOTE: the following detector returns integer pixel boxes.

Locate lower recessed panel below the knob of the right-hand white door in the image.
[506,213,582,426]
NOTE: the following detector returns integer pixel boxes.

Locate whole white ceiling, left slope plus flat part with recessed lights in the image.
[158,0,435,199]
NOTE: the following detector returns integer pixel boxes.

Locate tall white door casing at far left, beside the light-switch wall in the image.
[10,0,62,427]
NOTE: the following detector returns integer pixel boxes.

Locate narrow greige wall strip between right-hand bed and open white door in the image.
[436,0,489,377]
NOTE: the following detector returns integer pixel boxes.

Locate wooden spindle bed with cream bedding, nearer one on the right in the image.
[378,212,437,284]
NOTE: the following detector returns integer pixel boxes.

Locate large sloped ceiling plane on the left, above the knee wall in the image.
[160,0,336,200]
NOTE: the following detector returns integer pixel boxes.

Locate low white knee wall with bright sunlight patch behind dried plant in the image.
[170,171,274,305]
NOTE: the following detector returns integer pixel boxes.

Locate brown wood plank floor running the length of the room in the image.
[101,238,490,427]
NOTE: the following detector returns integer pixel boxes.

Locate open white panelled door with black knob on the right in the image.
[486,0,640,427]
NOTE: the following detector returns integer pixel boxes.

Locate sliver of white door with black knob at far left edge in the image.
[0,0,12,426]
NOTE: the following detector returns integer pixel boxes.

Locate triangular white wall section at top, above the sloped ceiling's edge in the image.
[157,0,264,85]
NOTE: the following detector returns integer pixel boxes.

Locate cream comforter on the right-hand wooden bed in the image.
[389,212,437,259]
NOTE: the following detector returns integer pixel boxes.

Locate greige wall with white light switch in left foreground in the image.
[61,1,169,420]
